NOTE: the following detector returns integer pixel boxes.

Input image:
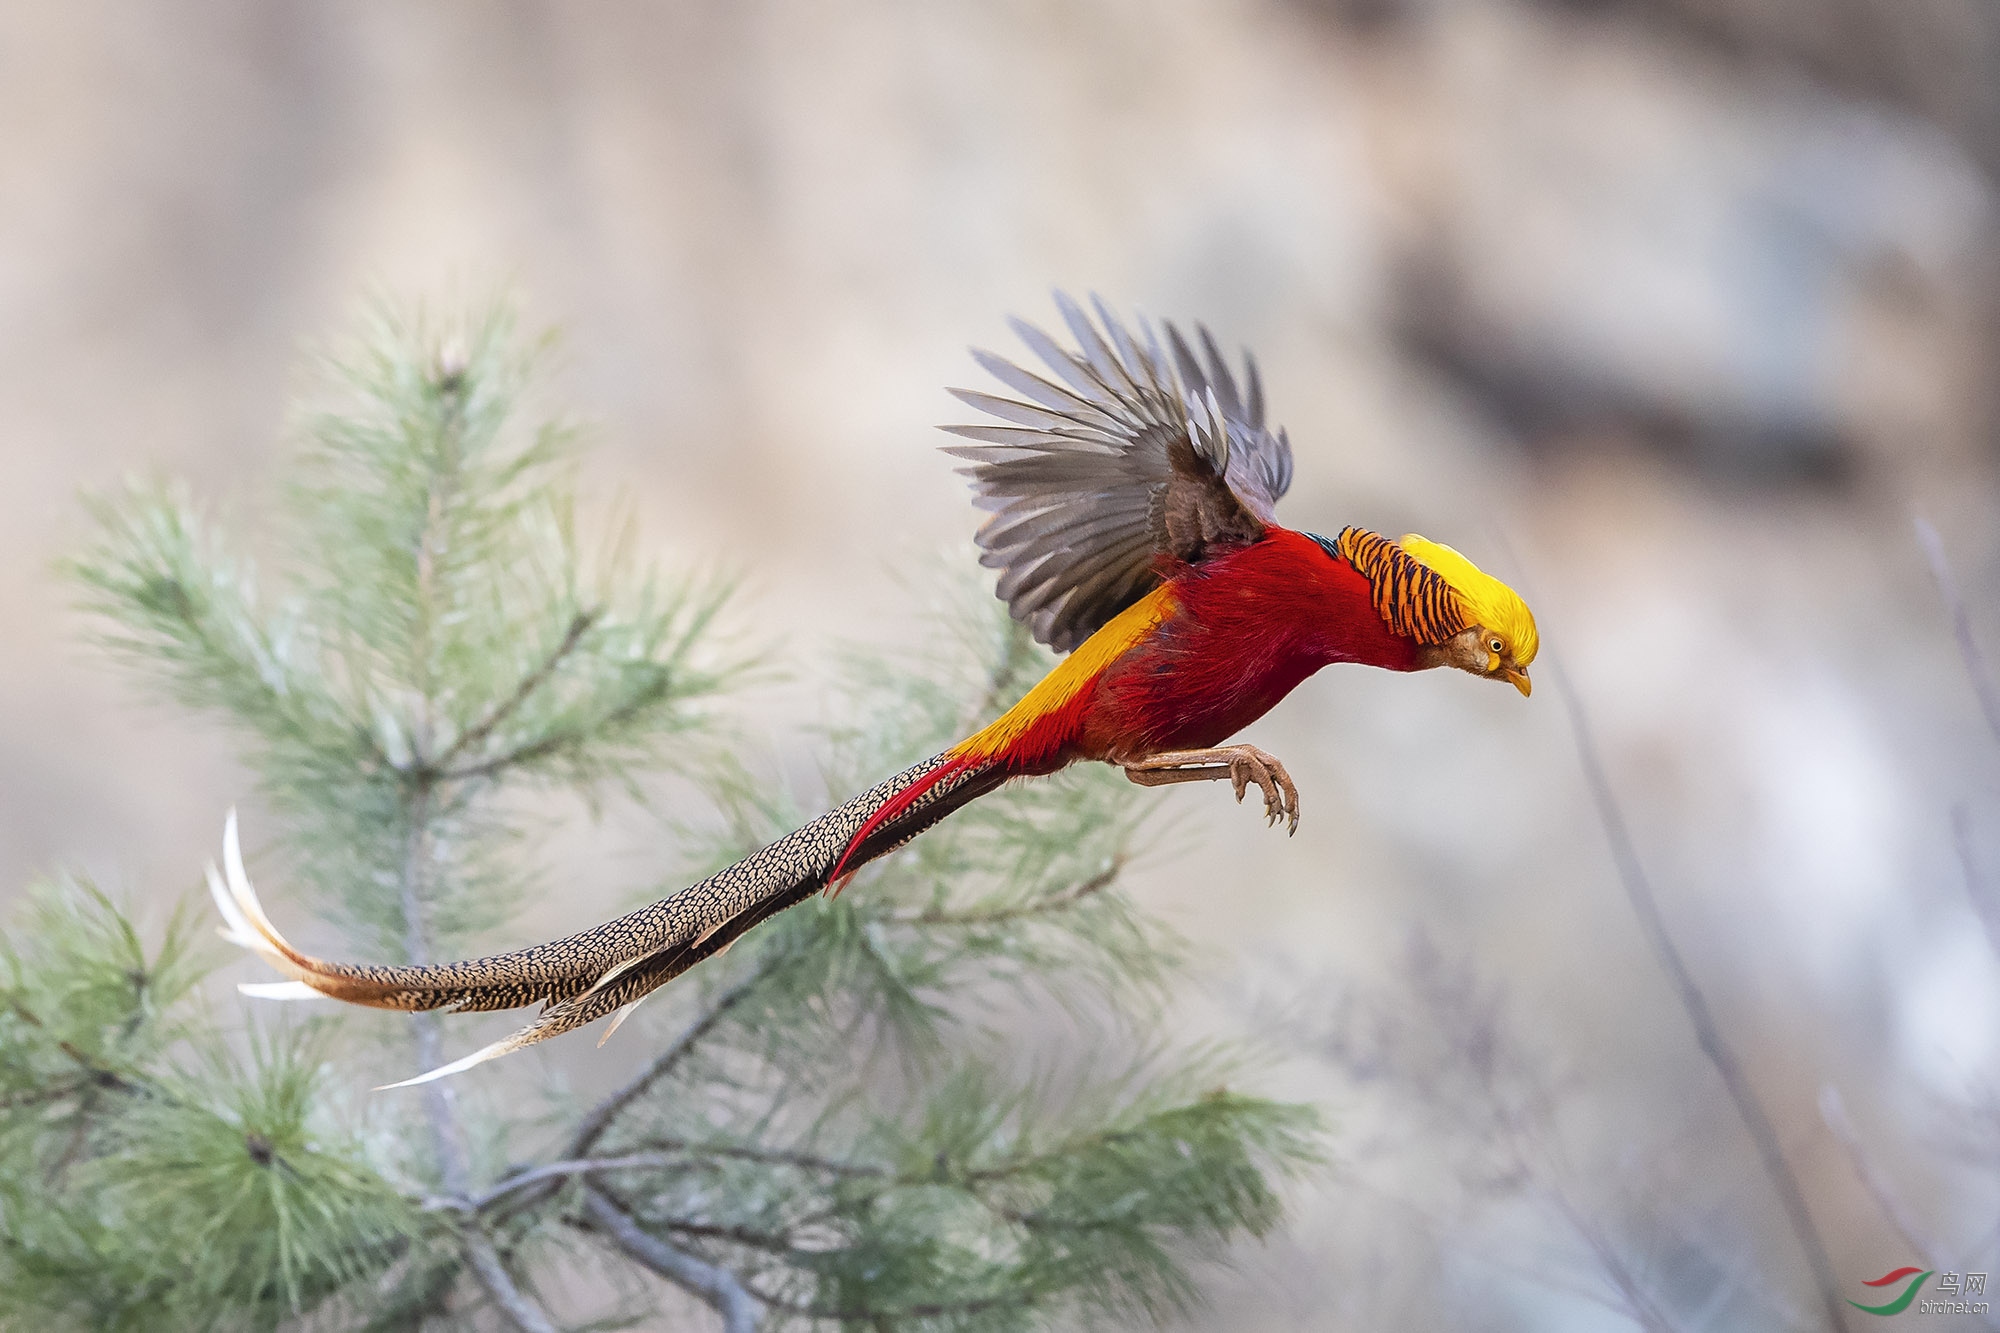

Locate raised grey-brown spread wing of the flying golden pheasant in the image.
[946,292,1292,652]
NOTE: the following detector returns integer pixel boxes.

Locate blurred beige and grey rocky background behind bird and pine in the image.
[0,0,2000,1329]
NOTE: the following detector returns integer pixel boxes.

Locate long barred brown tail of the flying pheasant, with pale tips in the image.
[208,755,1006,1087]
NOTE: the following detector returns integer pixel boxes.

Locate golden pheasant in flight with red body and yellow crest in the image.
[208,292,1540,1083]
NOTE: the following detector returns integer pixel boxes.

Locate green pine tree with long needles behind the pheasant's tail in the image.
[0,300,1314,1331]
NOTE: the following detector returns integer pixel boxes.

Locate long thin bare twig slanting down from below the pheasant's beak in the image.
[1544,652,1846,1331]
